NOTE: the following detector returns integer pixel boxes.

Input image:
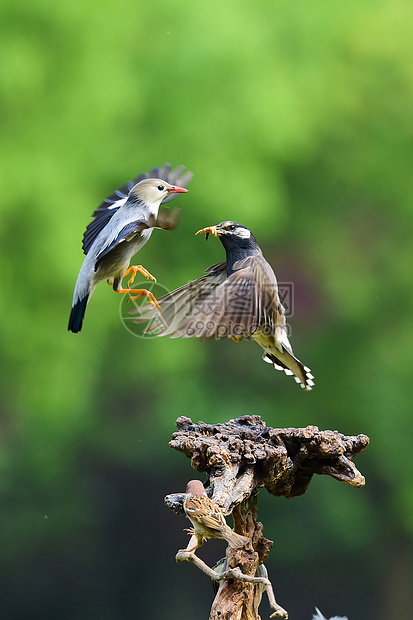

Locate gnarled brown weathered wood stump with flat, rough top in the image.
[165,415,369,620]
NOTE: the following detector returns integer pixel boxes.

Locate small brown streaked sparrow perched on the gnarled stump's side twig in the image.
[182,480,250,553]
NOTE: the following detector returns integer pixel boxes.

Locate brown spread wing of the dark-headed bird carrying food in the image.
[132,257,285,340]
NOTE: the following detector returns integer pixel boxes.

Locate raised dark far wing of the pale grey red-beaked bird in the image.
[82,163,194,254]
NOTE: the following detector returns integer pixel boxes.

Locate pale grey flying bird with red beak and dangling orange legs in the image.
[68,164,193,333]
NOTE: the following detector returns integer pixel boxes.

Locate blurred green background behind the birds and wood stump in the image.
[0,0,413,620]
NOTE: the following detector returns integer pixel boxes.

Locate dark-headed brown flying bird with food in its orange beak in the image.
[131,221,314,390]
